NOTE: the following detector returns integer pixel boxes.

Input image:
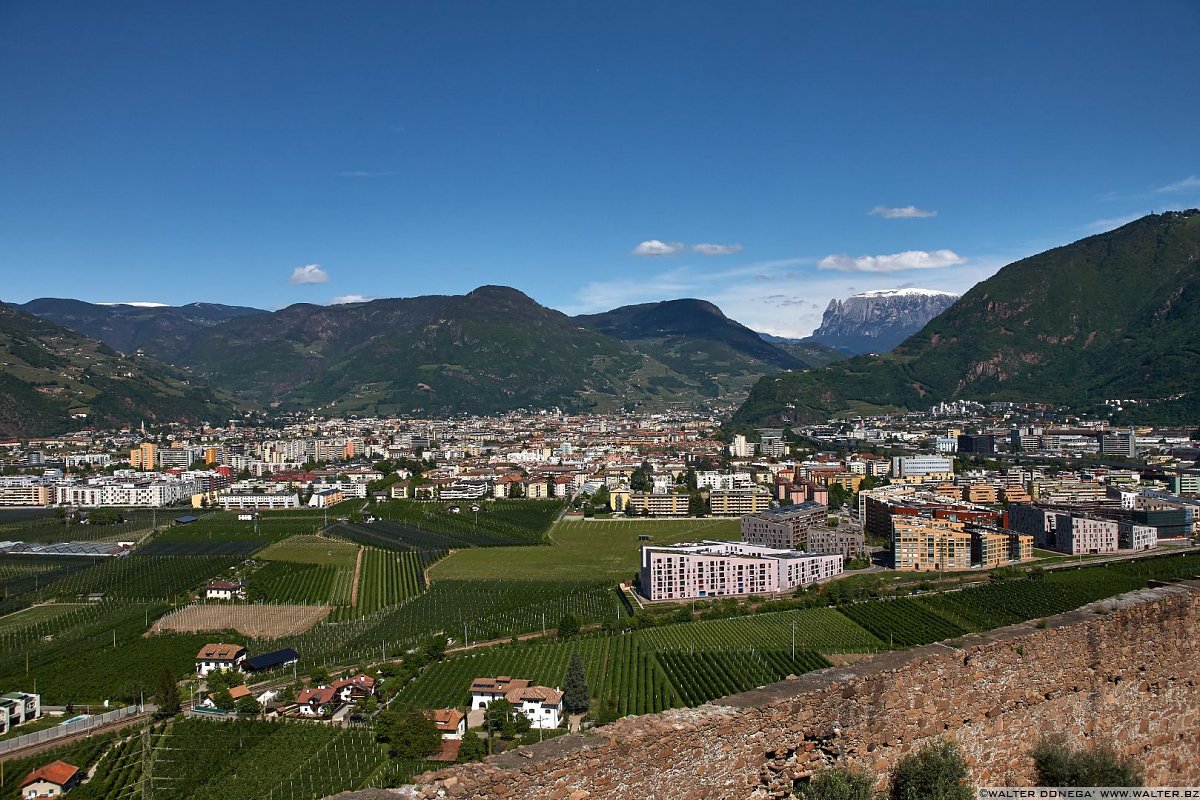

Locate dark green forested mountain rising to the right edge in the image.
[736,210,1200,423]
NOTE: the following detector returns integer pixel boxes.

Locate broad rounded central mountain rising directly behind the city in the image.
[145,287,791,414]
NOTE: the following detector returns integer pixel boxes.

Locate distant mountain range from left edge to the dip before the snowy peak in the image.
[0,287,808,435]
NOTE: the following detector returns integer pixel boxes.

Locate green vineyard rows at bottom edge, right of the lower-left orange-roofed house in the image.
[149,720,386,800]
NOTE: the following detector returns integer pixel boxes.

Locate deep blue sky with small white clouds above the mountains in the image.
[0,0,1200,335]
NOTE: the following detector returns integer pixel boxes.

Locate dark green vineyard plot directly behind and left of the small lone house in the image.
[46,555,240,600]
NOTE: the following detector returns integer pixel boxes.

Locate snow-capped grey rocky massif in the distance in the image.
[811,289,958,353]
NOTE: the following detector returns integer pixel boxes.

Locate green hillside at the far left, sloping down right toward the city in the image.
[0,303,232,437]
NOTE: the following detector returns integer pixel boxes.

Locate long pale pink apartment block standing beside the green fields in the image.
[641,541,842,600]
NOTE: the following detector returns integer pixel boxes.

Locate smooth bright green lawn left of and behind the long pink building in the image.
[428,519,742,582]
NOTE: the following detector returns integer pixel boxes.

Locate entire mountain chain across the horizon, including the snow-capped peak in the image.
[9,210,1200,437]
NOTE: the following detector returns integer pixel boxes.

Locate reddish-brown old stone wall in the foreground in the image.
[402,582,1200,800]
